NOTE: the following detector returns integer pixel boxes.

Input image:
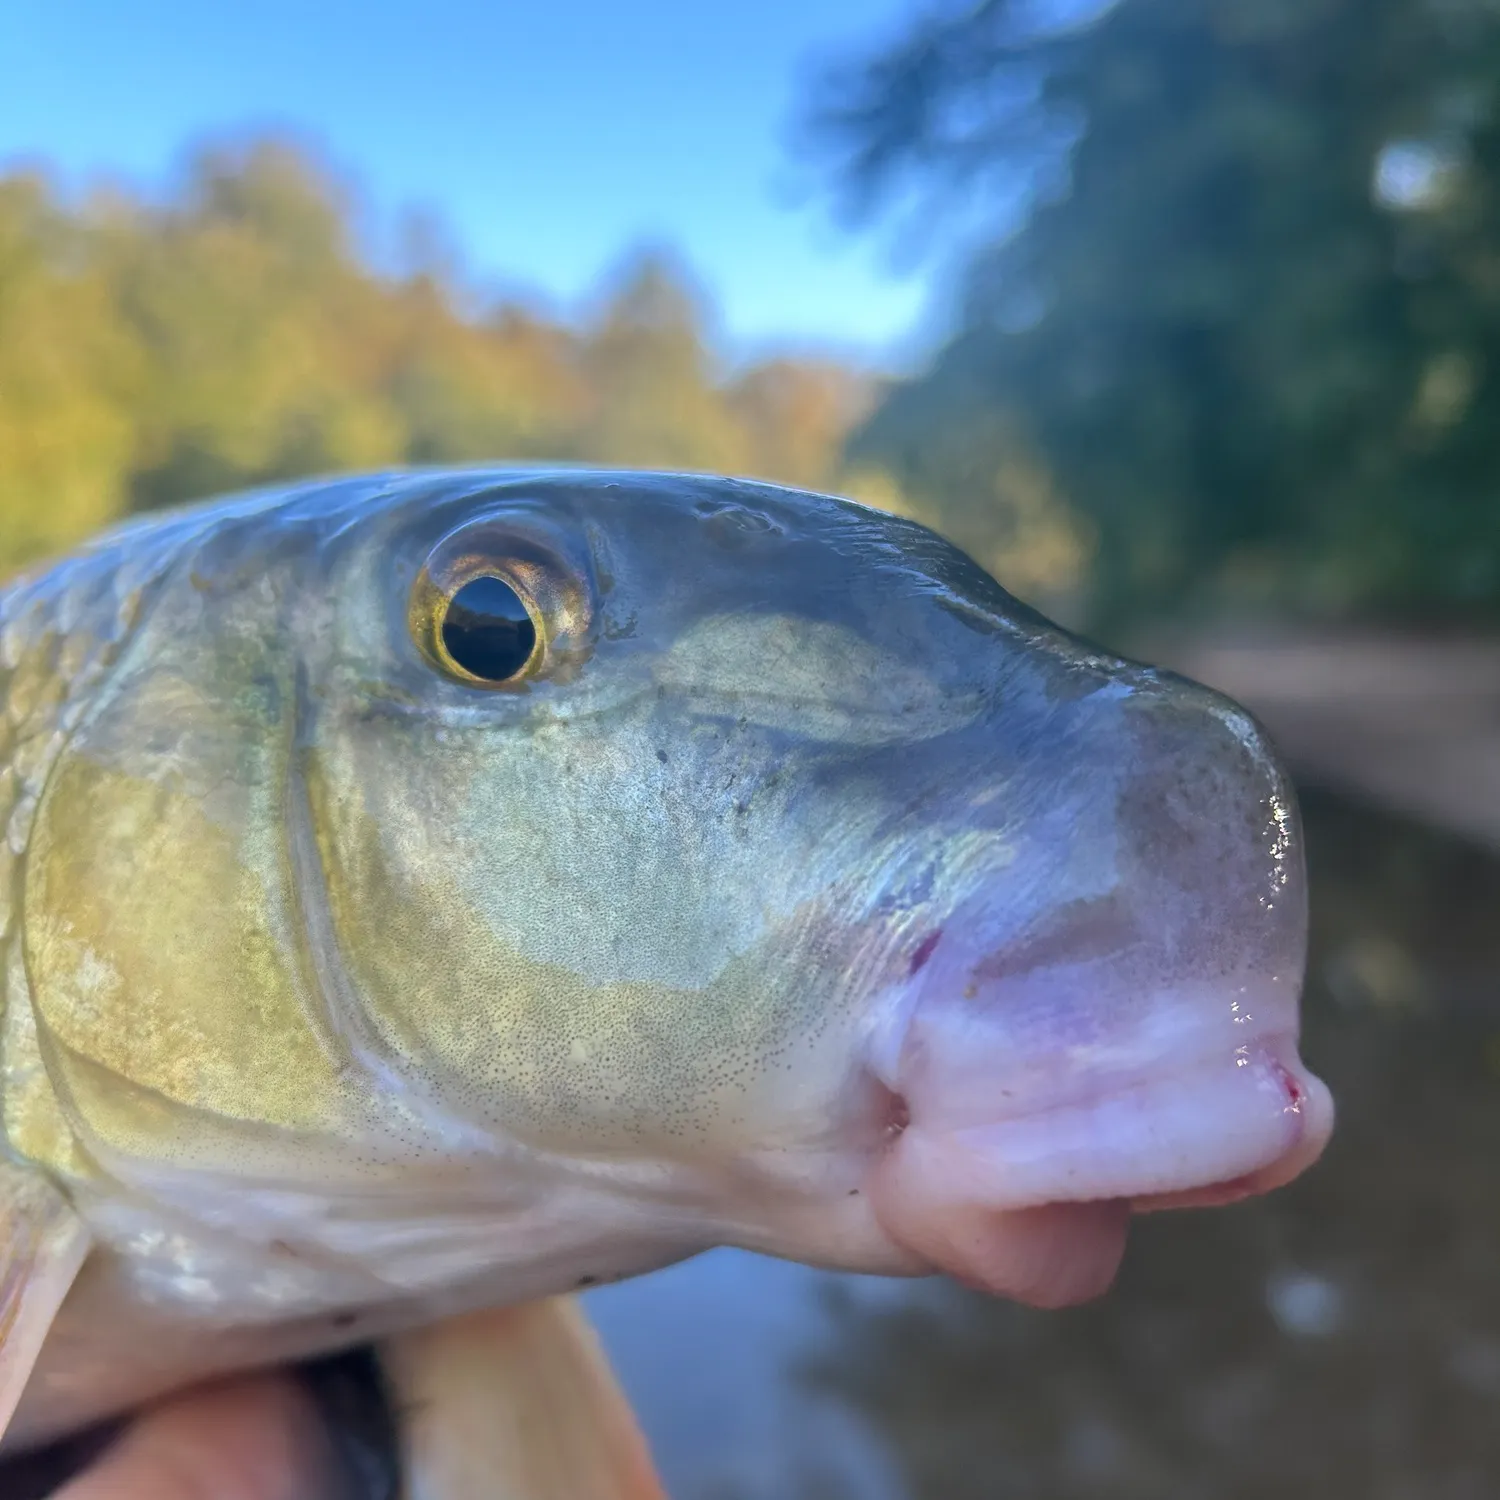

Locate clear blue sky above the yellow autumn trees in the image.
[0,0,926,363]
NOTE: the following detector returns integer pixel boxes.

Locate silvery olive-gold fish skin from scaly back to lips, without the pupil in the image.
[0,470,1332,1445]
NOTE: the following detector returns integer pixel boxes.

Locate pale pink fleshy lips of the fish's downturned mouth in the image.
[870,1032,1334,1307]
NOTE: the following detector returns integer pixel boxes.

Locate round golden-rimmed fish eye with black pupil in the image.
[407,518,596,692]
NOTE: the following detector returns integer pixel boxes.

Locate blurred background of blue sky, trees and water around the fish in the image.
[0,0,1500,1500]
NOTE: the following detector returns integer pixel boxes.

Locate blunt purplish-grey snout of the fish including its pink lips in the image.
[870,680,1334,1305]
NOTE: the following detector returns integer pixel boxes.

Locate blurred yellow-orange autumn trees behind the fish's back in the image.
[0,141,875,573]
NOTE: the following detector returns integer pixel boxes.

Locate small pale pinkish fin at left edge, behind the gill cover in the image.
[0,1163,90,1436]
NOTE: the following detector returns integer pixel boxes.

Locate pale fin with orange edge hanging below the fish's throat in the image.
[381,1298,666,1500]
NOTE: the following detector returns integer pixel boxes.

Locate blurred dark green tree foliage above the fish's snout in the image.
[815,0,1500,623]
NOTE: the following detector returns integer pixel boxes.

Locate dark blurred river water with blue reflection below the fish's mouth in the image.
[591,794,1500,1500]
